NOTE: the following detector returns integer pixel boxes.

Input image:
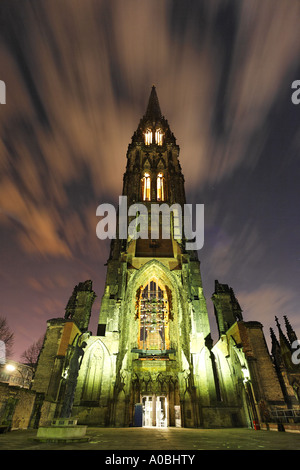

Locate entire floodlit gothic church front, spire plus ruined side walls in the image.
[32,87,298,427]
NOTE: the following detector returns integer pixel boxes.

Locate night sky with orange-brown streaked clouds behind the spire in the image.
[0,0,300,360]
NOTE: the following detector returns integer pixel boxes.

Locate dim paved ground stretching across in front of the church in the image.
[0,427,300,455]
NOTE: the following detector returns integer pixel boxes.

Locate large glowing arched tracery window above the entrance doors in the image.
[138,279,169,351]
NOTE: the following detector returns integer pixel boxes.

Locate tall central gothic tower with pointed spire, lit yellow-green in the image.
[91,86,225,427]
